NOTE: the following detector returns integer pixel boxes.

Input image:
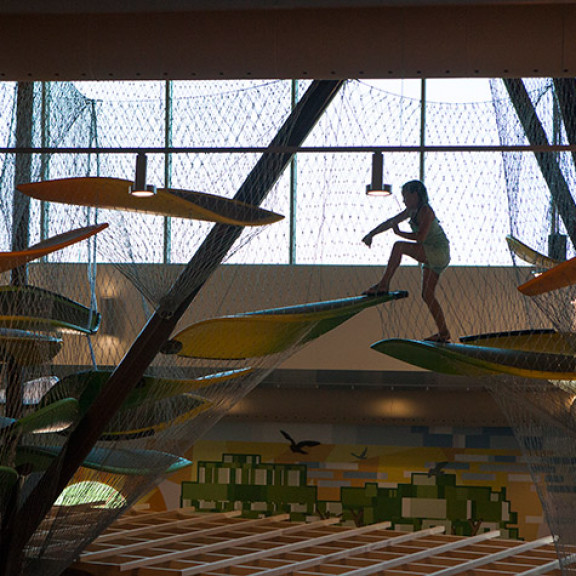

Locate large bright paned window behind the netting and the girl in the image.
[0,79,573,265]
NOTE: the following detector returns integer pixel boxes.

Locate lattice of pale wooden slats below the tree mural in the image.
[75,511,576,576]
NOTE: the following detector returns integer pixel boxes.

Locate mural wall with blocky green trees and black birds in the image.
[139,422,548,540]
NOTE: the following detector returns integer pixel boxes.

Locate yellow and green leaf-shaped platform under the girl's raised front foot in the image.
[161,291,408,360]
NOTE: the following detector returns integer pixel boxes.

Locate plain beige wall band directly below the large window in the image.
[30,264,549,372]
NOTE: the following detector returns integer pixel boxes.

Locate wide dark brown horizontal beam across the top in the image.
[0,5,576,81]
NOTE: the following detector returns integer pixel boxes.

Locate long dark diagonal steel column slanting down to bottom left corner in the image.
[0,80,343,576]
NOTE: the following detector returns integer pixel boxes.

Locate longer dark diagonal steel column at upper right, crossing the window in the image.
[503,78,576,246]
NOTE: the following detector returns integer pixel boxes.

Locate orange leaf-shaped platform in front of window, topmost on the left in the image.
[17,177,284,226]
